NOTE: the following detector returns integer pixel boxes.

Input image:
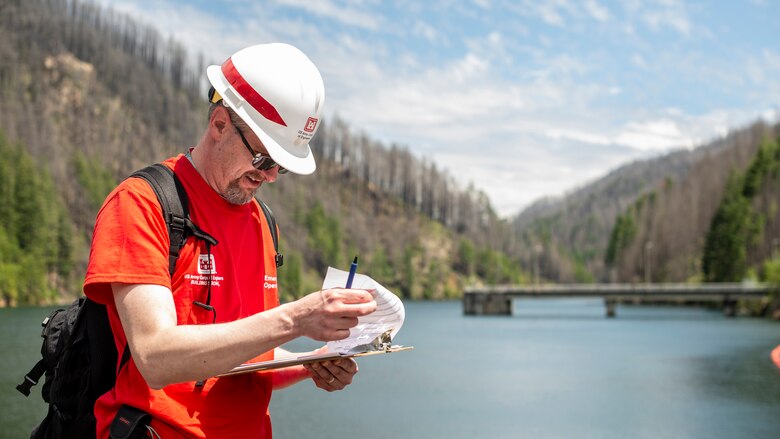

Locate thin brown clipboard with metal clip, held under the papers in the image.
[217,331,414,377]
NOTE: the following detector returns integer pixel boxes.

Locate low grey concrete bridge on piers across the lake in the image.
[463,283,777,317]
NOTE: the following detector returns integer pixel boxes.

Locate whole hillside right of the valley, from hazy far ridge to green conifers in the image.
[515,118,780,288]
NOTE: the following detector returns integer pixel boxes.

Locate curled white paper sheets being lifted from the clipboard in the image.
[322,267,406,354]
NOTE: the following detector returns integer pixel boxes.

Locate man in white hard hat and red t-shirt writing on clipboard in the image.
[84,44,376,439]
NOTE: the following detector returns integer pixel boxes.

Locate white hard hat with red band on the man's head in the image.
[206,43,325,175]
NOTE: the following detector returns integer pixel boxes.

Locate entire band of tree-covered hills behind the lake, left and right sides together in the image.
[0,0,780,310]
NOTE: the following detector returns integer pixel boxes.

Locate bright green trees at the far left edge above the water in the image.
[0,133,74,304]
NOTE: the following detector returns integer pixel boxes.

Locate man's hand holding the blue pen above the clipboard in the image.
[288,288,376,342]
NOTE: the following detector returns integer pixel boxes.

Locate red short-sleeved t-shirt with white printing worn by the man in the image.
[84,155,278,439]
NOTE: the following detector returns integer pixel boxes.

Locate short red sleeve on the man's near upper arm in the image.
[84,178,171,305]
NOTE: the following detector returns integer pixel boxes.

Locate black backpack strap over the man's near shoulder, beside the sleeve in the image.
[130,163,217,276]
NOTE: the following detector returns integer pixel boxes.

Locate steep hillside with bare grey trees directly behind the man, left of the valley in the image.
[0,0,524,304]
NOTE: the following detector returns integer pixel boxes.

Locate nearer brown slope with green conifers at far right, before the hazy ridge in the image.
[607,123,780,282]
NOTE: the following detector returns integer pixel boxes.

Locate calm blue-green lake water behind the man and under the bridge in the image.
[0,300,780,439]
